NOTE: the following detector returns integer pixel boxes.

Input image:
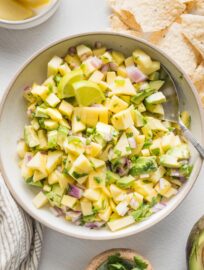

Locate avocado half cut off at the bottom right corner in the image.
[186,216,204,270]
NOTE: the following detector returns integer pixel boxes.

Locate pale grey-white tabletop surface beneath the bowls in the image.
[0,0,204,270]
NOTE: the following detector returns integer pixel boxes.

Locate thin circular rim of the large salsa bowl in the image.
[0,31,204,240]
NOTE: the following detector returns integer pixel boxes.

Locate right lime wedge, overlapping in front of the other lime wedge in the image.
[73,80,105,106]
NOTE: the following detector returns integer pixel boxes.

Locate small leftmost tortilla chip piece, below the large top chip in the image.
[110,14,142,37]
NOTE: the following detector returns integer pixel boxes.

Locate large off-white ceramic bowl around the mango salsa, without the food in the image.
[0,32,204,240]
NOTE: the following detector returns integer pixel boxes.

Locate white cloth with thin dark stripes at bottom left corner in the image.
[0,177,43,270]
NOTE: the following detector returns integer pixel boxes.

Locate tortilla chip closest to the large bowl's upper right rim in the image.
[156,23,198,75]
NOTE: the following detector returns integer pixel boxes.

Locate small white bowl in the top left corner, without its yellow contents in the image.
[0,0,60,30]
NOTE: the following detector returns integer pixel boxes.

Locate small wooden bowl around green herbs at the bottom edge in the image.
[86,248,153,270]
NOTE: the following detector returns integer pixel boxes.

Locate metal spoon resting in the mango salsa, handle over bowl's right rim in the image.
[162,67,204,159]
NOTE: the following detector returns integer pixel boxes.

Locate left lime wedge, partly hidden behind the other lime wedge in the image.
[58,68,84,99]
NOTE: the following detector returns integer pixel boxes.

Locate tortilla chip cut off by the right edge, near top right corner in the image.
[181,14,204,58]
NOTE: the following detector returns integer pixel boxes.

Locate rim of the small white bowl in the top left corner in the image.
[0,0,61,26]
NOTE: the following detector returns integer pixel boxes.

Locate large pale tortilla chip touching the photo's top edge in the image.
[109,0,186,32]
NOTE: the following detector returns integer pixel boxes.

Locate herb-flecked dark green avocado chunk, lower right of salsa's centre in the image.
[130,157,158,176]
